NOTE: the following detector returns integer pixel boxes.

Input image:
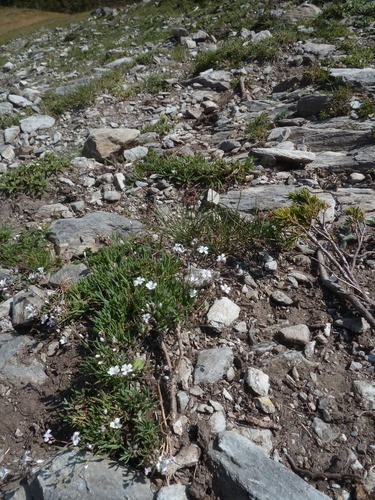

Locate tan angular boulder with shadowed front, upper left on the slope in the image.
[82,128,140,161]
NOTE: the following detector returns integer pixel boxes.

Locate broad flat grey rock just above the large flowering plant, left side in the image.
[49,212,143,256]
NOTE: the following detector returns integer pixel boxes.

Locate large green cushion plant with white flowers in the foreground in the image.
[58,239,197,465]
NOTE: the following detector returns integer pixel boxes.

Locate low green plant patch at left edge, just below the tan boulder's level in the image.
[0,153,70,197]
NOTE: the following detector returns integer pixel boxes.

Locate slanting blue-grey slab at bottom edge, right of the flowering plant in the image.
[209,431,329,500]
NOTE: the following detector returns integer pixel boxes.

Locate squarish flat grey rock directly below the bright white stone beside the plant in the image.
[194,347,233,384]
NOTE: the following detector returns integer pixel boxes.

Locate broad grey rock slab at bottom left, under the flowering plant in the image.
[8,451,154,500]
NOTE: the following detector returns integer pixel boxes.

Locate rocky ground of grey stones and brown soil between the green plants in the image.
[0,2,375,499]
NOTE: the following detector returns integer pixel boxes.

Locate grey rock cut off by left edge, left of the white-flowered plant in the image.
[0,333,47,387]
